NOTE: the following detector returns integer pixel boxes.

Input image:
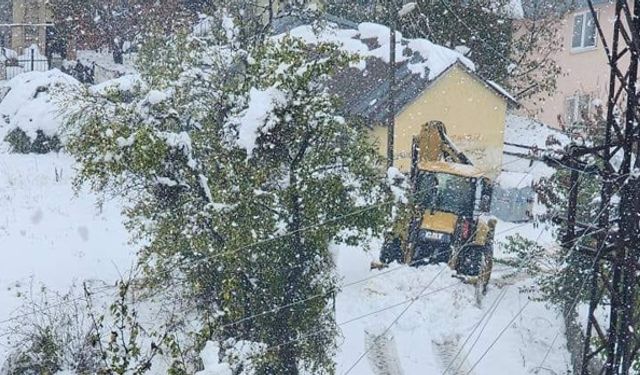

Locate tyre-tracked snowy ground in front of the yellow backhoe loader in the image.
[334,223,570,375]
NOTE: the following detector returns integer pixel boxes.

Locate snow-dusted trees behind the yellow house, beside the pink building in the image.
[329,0,561,106]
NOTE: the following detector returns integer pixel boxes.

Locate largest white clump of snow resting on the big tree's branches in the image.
[225,87,287,157]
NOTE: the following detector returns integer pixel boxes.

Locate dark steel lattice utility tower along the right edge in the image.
[566,0,640,375]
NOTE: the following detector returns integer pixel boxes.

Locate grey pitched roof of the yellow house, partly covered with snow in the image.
[273,19,500,123]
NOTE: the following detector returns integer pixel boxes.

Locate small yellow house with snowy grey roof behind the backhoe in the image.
[278,16,517,178]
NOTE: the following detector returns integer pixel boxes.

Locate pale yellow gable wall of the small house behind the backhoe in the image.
[372,66,507,178]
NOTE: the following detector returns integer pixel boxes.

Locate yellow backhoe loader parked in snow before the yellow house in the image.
[380,121,496,293]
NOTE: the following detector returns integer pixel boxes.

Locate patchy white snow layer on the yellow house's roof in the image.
[274,22,475,79]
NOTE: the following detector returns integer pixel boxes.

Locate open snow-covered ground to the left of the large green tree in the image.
[0,151,135,366]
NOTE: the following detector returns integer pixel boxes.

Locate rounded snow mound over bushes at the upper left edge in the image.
[0,69,80,141]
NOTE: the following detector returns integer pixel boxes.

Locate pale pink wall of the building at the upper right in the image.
[522,4,624,127]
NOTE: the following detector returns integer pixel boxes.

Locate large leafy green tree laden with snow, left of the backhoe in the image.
[62,16,386,374]
